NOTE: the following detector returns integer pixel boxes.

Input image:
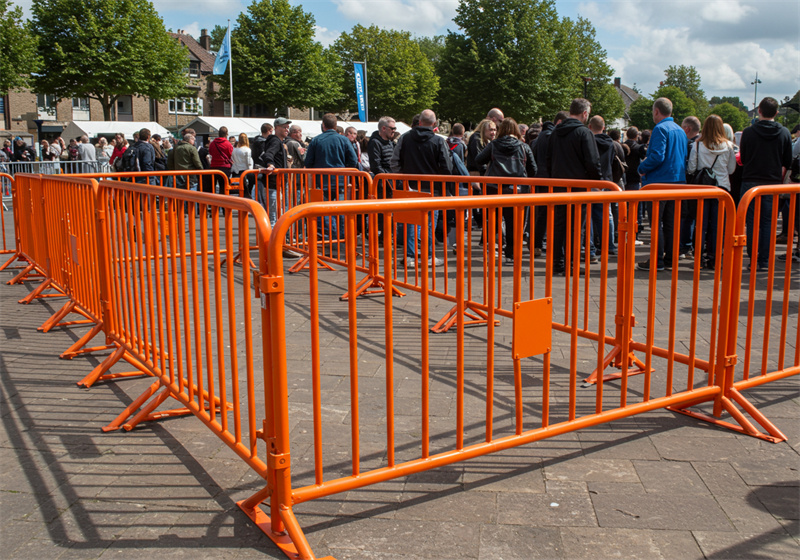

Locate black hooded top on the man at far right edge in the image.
[739,120,792,184]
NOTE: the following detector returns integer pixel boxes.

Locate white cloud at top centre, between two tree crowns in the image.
[333,0,458,35]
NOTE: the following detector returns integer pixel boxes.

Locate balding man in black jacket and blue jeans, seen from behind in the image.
[397,109,453,268]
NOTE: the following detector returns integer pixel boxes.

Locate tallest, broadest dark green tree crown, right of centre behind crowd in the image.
[437,0,624,126]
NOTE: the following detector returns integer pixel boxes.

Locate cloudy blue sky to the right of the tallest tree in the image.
[579,0,800,103]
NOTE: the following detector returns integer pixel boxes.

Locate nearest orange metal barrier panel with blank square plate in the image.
[252,186,733,557]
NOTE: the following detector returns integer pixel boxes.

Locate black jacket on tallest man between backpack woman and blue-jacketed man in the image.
[547,118,600,180]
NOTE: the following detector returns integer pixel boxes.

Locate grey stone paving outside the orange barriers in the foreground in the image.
[0,203,800,560]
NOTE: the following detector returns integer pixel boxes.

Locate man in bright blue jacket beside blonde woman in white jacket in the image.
[639,97,688,270]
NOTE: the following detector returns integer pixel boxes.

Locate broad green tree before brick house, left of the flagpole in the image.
[31,0,188,120]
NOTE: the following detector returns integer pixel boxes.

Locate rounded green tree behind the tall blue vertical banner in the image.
[332,25,439,121]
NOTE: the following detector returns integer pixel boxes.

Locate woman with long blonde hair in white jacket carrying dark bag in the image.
[687,115,736,270]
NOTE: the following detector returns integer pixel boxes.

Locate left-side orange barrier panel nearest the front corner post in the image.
[96,181,270,468]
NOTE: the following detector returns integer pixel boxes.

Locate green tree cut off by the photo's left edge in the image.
[0,0,41,95]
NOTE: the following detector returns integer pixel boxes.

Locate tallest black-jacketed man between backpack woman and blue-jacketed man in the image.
[546,98,600,274]
